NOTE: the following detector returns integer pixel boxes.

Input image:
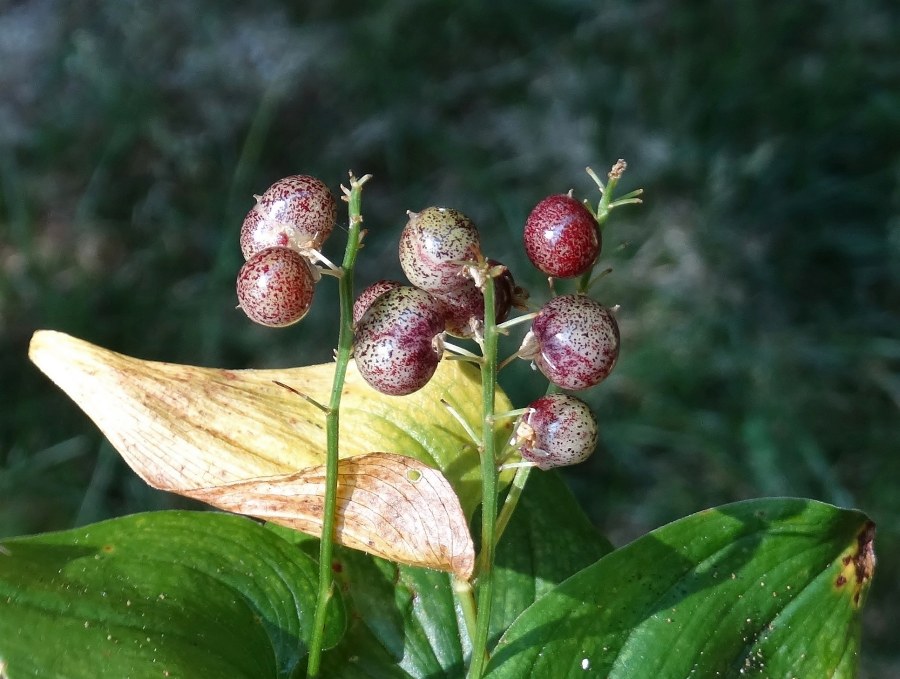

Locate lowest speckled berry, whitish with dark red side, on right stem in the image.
[515,394,597,469]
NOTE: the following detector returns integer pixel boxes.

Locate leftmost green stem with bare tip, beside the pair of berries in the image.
[306,172,371,679]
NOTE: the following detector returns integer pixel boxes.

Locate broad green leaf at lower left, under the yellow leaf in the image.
[0,512,345,679]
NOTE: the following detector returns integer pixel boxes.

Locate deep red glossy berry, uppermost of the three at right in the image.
[524,195,601,278]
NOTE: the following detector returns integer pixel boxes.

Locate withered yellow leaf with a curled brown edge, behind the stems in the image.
[29,331,512,576]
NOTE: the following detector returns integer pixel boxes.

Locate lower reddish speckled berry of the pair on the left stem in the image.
[237,248,317,328]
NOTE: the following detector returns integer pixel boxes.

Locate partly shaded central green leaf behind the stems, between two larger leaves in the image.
[312,471,611,679]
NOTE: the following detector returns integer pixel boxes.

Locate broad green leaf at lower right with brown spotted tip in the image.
[488,499,875,679]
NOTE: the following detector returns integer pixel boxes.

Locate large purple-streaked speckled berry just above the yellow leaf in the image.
[353,286,444,396]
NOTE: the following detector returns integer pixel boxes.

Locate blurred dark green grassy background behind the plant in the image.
[0,0,900,677]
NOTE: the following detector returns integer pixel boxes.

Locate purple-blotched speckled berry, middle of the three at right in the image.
[519,295,619,391]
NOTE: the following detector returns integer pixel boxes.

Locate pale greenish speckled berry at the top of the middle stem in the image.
[399,207,481,294]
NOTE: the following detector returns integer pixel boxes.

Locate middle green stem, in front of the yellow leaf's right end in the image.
[468,276,498,679]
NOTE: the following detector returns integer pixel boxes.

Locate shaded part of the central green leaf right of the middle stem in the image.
[491,469,612,643]
